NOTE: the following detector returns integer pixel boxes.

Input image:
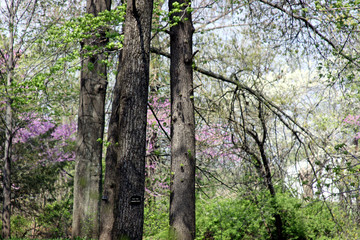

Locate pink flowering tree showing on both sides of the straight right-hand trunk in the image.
[146,96,241,197]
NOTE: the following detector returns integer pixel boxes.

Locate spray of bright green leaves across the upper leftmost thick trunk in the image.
[37,5,126,77]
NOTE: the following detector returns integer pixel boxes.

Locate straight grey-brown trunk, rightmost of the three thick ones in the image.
[169,0,195,240]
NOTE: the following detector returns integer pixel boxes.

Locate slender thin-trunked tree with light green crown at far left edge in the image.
[0,0,81,238]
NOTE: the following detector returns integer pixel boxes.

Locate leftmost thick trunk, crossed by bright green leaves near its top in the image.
[72,0,111,239]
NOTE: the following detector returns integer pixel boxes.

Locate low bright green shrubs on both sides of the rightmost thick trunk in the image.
[144,192,360,240]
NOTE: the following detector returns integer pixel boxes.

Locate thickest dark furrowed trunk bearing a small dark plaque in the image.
[100,0,153,240]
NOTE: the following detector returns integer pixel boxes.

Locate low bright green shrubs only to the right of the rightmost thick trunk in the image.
[197,193,359,239]
